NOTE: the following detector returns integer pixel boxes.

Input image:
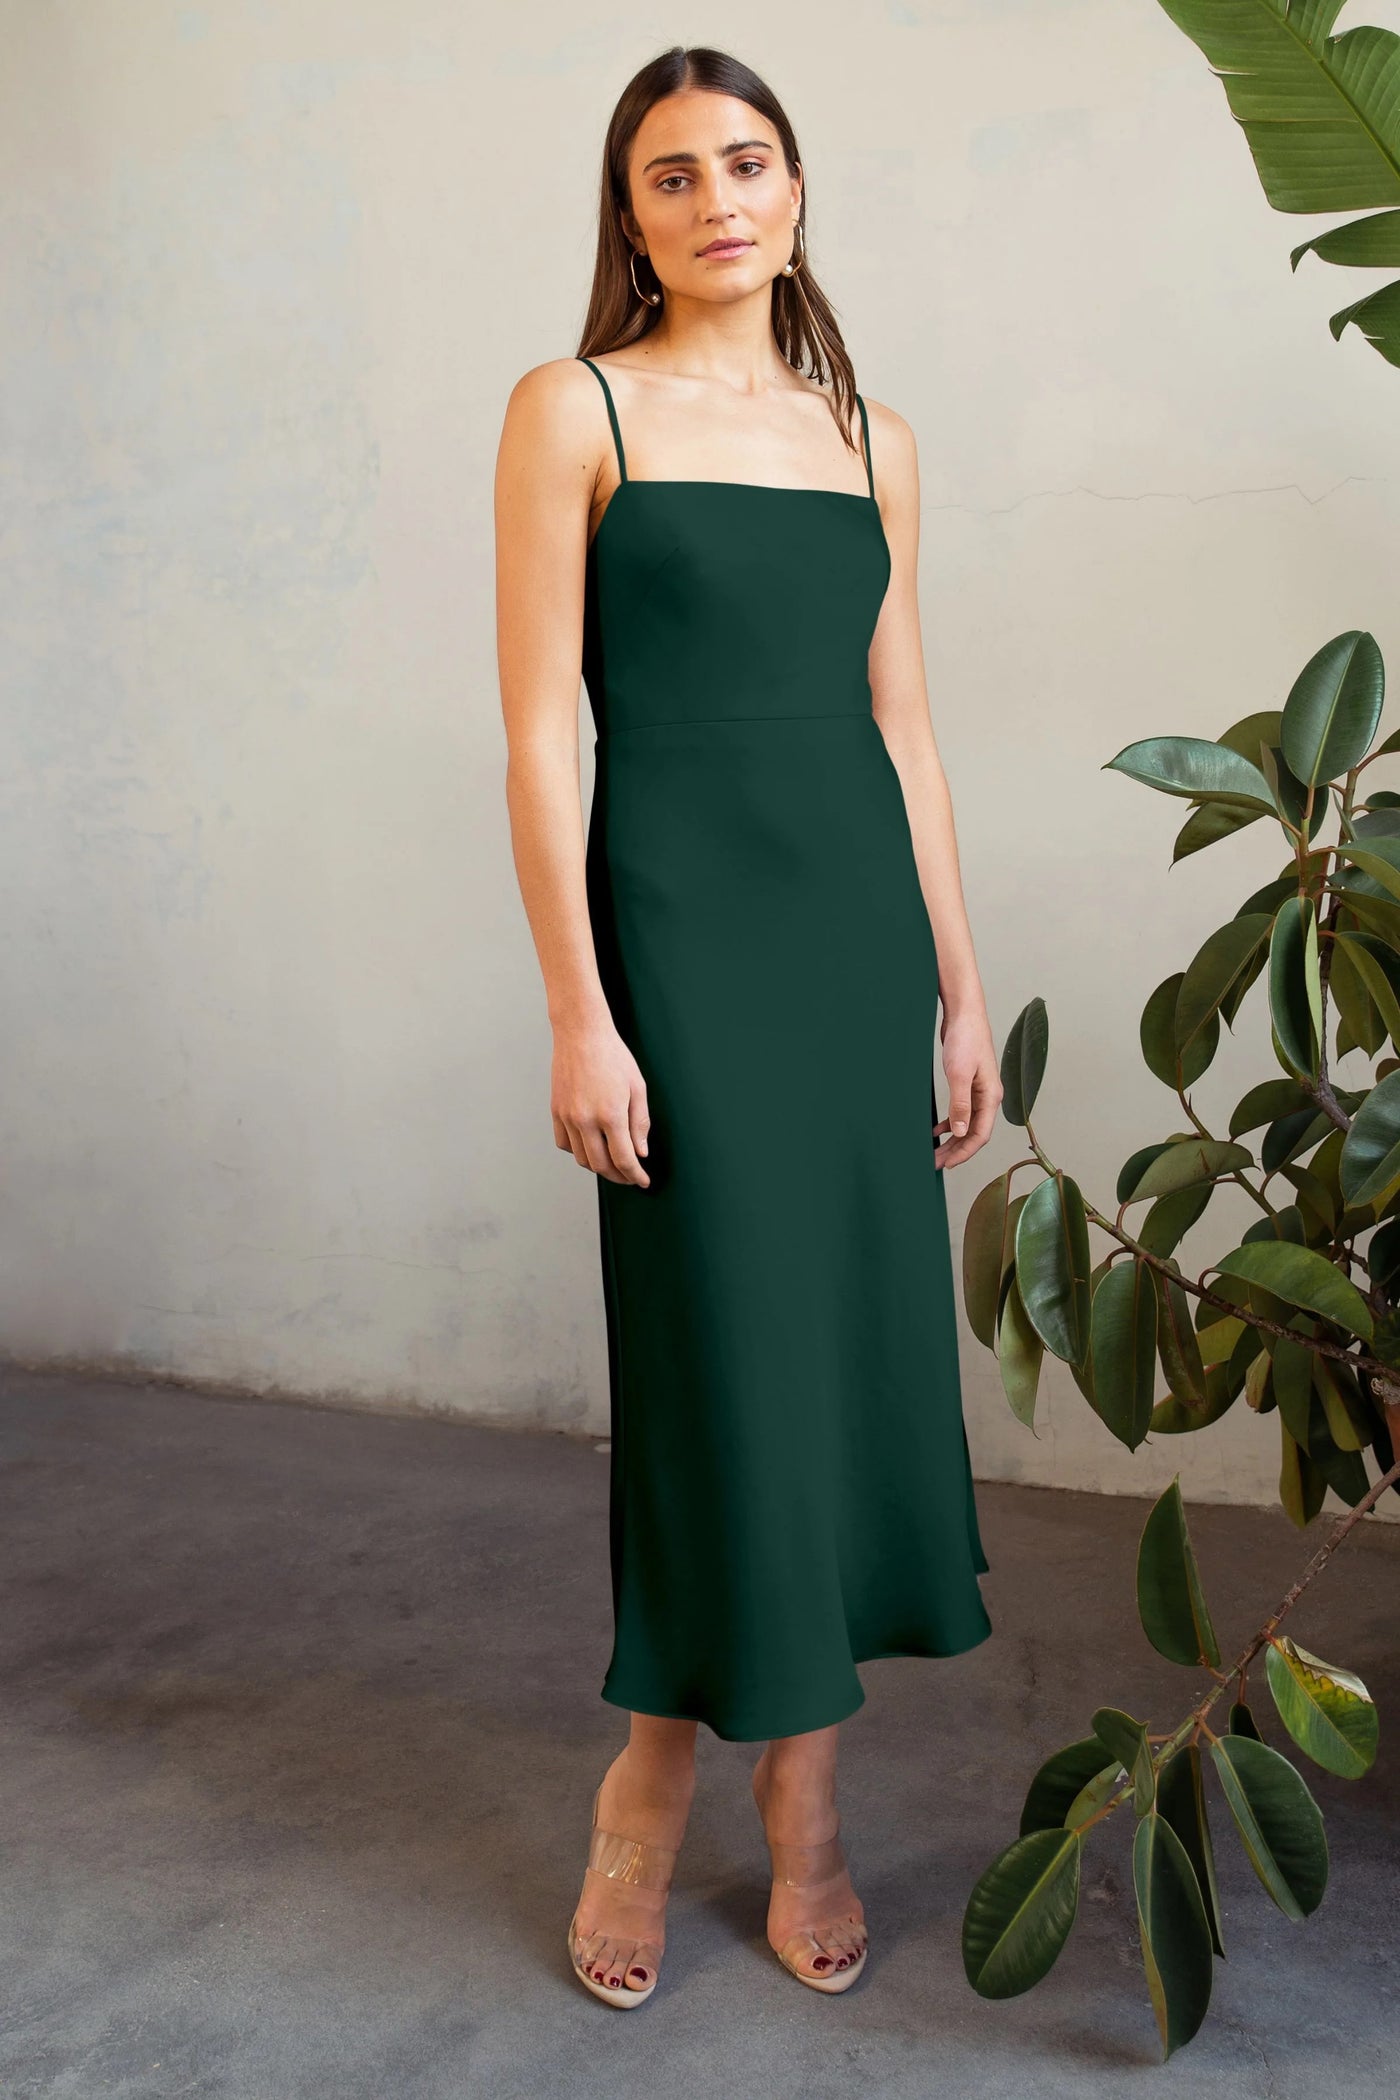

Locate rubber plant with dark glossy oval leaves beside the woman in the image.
[963,632,1400,2056]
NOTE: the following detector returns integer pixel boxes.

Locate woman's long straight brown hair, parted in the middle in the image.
[577,44,858,452]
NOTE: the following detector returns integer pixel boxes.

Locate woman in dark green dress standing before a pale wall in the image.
[497,48,1001,2008]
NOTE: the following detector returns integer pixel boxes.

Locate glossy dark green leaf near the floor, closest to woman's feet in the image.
[963,1829,1081,1997]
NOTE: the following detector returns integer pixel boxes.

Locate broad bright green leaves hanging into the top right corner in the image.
[1159,0,1400,365]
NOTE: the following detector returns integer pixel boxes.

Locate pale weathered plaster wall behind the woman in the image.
[0,0,1400,1499]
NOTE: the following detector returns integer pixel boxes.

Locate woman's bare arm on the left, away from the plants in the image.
[495,357,649,1187]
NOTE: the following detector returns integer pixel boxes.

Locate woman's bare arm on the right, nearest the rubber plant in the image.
[867,399,1001,1168]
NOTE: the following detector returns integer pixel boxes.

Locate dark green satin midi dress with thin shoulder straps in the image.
[584,359,991,1741]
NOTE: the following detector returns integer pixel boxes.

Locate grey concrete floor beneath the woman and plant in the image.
[0,1373,1400,2100]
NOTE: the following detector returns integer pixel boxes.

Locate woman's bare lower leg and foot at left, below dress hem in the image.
[575,1714,697,1991]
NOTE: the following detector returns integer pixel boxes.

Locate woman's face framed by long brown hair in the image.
[623,88,802,300]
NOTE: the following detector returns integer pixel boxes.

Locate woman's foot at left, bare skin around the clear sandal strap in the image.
[573,1747,695,1991]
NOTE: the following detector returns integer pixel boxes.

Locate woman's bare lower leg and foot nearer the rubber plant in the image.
[754,1722,865,1976]
